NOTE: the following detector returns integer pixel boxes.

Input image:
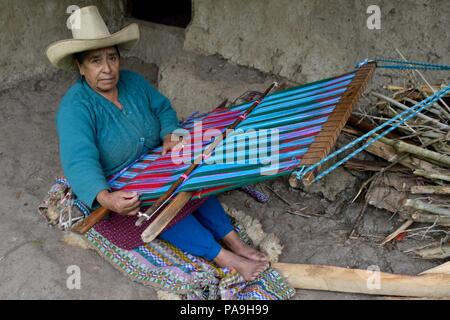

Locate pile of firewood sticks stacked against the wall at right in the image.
[345,71,450,259]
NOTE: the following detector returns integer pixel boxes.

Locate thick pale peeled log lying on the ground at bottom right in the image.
[272,263,450,298]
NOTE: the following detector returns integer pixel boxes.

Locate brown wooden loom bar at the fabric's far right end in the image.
[289,62,376,188]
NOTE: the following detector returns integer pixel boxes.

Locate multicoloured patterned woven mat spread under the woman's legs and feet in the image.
[85,218,295,300]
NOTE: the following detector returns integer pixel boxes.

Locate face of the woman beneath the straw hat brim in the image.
[77,47,120,92]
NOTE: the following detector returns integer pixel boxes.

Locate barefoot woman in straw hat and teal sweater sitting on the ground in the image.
[47,6,268,281]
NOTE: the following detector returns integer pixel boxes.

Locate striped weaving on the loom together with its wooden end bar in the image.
[73,63,376,242]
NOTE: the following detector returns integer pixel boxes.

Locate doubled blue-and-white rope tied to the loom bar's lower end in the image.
[295,85,450,182]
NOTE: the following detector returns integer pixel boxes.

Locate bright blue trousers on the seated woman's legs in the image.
[159,196,233,261]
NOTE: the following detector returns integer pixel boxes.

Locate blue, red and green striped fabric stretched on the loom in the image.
[110,72,356,206]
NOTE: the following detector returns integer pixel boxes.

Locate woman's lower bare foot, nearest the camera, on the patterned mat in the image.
[214,248,268,281]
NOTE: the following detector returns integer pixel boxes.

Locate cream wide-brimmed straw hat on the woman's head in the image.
[46,6,139,70]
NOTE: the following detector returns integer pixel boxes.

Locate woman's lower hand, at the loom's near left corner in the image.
[97,190,141,216]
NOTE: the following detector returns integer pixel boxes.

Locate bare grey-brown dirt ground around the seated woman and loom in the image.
[0,56,439,300]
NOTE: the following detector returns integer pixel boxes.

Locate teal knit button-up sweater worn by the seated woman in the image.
[56,70,178,208]
